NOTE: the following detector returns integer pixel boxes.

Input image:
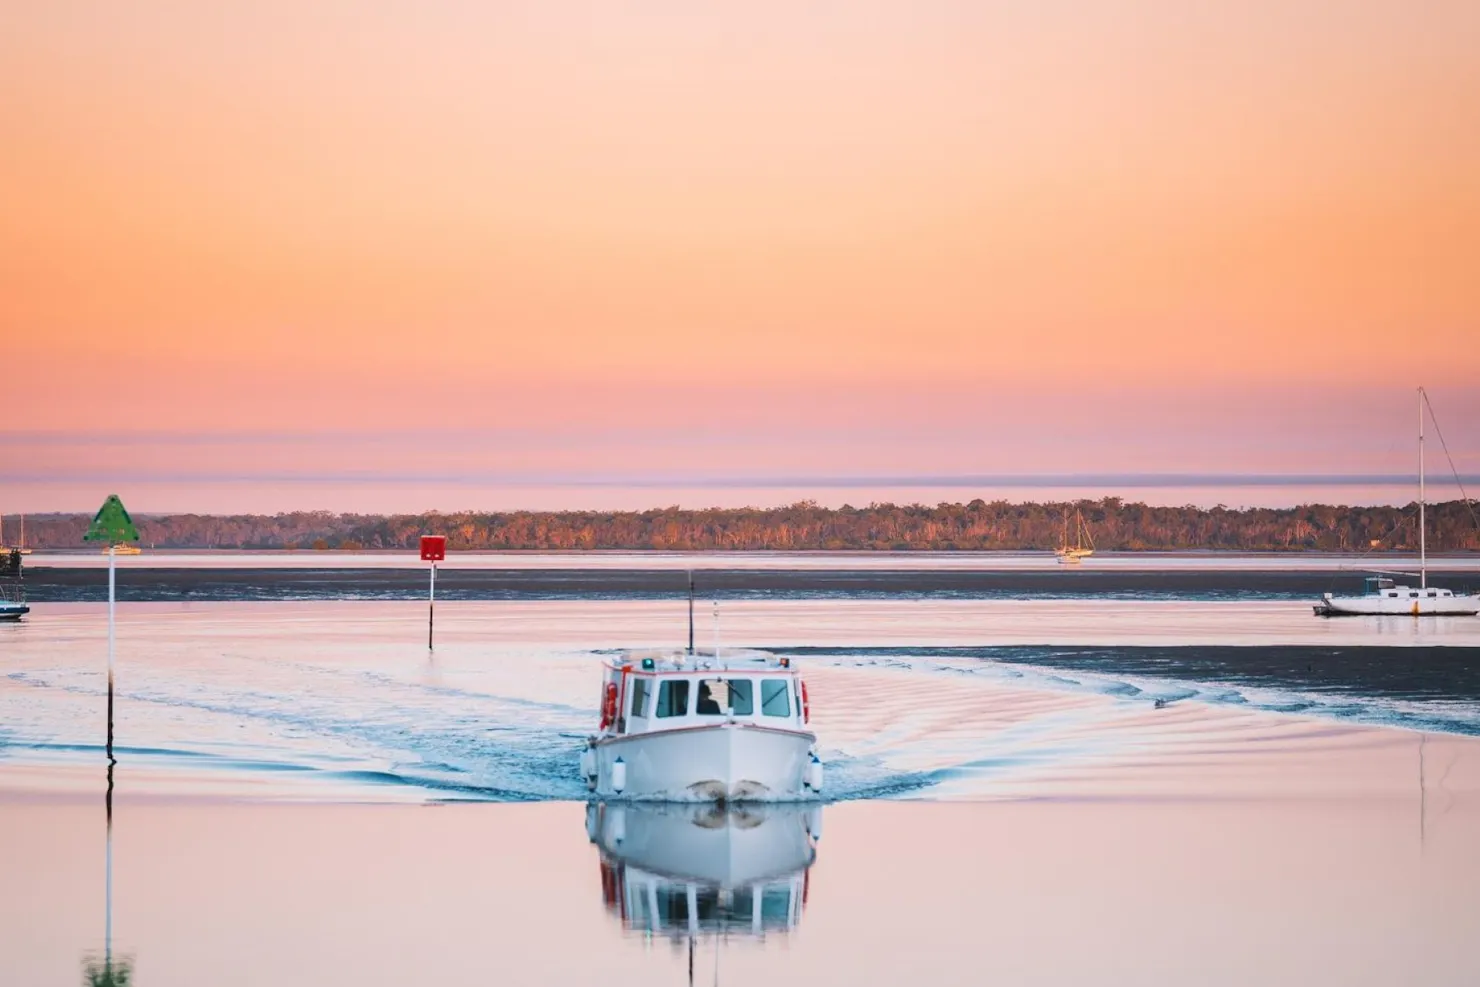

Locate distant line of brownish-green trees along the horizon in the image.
[4,497,1480,552]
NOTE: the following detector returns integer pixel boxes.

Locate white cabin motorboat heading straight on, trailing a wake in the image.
[580,648,823,802]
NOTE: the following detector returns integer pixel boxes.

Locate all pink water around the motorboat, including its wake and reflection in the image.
[0,599,1480,986]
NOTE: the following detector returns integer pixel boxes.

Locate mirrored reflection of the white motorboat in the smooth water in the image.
[586,802,821,946]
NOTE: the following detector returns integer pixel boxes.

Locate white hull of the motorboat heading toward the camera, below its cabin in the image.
[593,722,817,802]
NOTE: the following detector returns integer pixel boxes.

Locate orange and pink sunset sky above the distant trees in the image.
[0,0,1480,513]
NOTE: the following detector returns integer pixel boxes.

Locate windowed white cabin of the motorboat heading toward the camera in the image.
[601,651,811,737]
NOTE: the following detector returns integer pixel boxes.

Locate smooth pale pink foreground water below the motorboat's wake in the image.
[0,793,1480,987]
